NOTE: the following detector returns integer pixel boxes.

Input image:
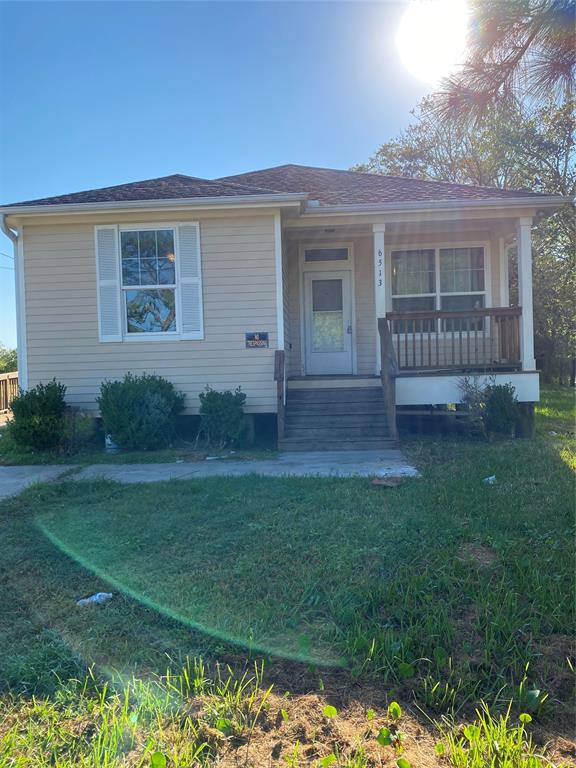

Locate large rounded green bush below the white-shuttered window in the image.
[98,373,185,451]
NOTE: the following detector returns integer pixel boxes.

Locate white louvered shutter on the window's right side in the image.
[178,223,204,339]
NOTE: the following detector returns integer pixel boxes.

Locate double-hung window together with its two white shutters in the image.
[96,223,203,341]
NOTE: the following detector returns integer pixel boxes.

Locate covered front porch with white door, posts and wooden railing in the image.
[276,210,538,450]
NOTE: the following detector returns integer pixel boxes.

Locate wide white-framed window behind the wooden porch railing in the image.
[391,246,486,333]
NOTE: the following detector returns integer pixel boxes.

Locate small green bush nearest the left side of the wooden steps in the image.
[200,387,246,448]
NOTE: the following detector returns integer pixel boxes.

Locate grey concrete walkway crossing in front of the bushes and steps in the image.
[0,449,418,499]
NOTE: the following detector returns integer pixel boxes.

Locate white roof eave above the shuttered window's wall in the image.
[0,192,308,216]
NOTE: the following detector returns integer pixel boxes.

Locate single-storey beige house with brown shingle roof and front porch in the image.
[0,165,566,449]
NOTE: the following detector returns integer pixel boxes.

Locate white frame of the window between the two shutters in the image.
[117,222,182,343]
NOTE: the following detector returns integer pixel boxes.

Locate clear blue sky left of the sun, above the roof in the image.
[0,0,430,346]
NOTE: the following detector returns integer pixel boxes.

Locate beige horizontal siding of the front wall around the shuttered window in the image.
[23,213,277,413]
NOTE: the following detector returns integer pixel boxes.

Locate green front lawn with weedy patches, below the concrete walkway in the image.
[0,391,576,768]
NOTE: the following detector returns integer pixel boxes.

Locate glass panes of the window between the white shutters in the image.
[120,229,177,333]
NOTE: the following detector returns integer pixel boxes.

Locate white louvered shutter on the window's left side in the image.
[95,227,122,341]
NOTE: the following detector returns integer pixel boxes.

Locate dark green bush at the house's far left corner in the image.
[9,379,66,451]
